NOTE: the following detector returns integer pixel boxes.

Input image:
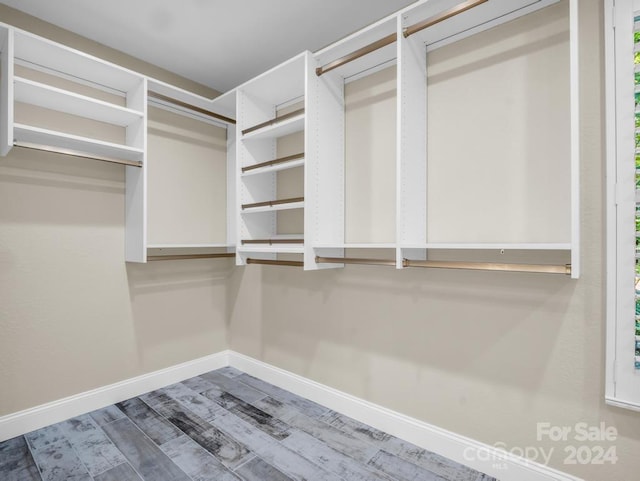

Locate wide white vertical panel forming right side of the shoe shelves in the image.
[304,54,345,270]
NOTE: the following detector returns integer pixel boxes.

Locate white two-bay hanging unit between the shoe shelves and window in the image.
[305,0,579,278]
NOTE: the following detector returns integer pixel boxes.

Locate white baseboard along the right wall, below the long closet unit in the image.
[229,351,583,481]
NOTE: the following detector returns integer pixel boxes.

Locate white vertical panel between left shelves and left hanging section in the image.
[125,77,148,262]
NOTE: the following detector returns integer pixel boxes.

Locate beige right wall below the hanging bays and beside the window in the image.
[228,0,640,481]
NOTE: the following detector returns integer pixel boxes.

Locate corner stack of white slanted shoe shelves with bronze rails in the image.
[236,52,311,265]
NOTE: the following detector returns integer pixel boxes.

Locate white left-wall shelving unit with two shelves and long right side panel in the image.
[0,25,147,261]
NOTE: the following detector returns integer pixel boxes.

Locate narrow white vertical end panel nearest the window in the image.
[569,0,580,279]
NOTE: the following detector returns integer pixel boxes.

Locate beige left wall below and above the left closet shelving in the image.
[0,5,232,416]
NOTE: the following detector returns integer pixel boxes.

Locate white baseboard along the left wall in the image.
[0,351,229,441]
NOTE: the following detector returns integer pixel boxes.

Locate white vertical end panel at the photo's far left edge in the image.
[0,27,14,156]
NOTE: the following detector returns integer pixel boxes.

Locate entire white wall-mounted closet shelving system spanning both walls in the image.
[0,0,580,278]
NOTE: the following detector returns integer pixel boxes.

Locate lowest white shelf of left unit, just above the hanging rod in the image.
[13,124,144,161]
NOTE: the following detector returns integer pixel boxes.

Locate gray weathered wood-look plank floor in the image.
[0,367,495,481]
